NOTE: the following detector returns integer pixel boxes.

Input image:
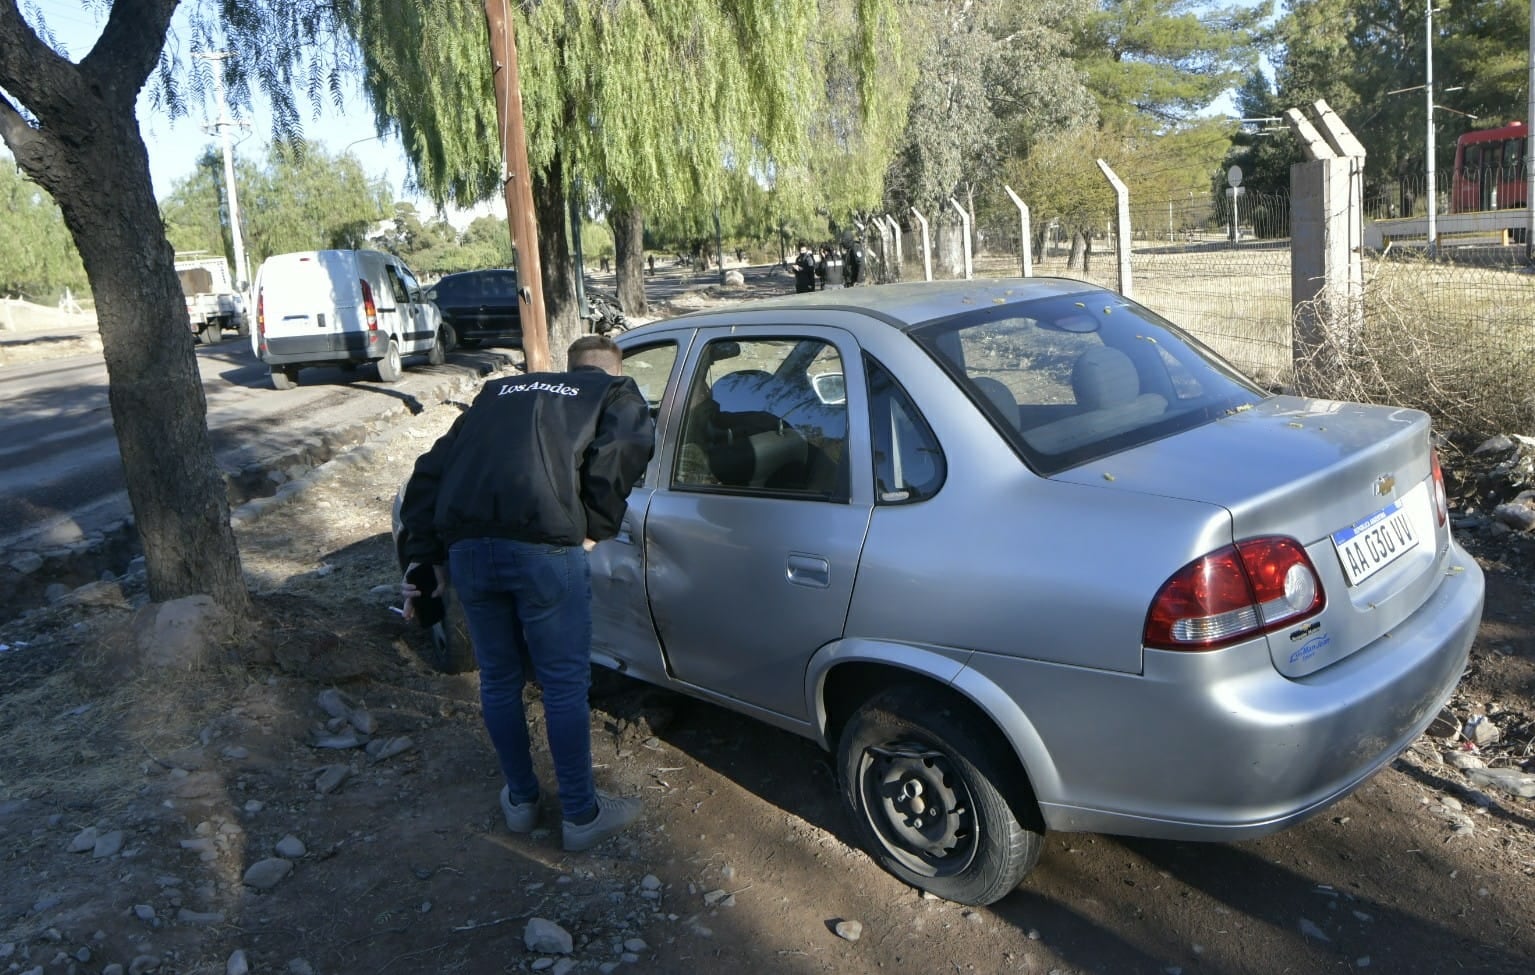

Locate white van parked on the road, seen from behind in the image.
[252,250,447,390]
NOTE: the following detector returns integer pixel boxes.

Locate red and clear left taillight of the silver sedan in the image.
[1145,536,1326,649]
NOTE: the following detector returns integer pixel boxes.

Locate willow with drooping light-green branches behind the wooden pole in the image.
[347,0,903,330]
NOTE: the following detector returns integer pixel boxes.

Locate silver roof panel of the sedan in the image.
[631,278,1102,333]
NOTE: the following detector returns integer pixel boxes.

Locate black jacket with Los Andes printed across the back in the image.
[401,367,655,565]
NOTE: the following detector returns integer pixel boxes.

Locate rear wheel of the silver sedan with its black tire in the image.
[837,685,1044,906]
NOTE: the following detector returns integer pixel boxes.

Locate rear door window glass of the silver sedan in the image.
[672,338,849,502]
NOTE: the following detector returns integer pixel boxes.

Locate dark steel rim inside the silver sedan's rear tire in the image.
[858,740,978,877]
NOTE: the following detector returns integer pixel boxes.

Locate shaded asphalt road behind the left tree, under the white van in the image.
[0,335,511,553]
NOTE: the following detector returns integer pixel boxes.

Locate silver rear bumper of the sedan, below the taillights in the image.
[958,547,1484,840]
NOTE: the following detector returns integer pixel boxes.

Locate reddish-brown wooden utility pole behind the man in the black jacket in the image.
[485,0,551,373]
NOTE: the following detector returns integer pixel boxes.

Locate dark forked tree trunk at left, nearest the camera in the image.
[0,3,250,616]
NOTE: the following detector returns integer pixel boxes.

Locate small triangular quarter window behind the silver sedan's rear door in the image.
[864,355,946,504]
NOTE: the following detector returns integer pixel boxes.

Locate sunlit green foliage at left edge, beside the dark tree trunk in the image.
[0,157,91,304]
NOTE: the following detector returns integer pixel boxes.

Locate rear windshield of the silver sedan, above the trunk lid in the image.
[912,292,1265,474]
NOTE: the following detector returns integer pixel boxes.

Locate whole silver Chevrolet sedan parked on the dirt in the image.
[389,278,1483,904]
